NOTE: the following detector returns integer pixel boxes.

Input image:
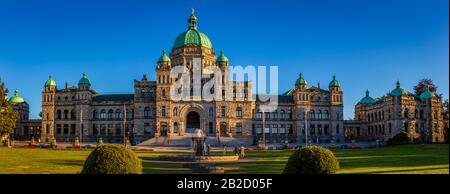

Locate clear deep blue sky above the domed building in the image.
[0,0,449,118]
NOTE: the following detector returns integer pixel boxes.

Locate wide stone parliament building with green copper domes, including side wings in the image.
[8,9,443,144]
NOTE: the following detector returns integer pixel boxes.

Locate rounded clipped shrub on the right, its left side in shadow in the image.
[283,146,339,174]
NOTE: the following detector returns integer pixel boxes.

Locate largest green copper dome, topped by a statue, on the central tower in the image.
[173,9,212,48]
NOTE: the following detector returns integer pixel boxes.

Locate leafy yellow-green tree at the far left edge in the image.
[0,79,19,145]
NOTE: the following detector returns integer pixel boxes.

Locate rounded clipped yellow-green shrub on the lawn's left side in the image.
[81,145,142,174]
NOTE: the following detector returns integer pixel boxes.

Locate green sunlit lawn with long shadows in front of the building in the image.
[0,144,449,174]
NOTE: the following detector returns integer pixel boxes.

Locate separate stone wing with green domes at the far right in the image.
[347,82,444,143]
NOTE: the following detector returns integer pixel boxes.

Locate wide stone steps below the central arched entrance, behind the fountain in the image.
[139,134,253,147]
